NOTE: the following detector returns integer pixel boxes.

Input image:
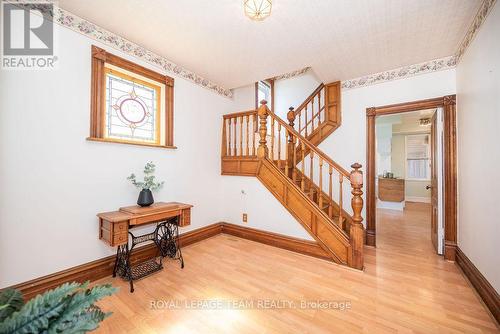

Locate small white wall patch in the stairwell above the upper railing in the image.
[274,70,321,120]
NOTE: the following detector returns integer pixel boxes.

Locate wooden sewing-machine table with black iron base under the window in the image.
[97,202,193,292]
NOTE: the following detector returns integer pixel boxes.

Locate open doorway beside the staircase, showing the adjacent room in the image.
[375,108,444,255]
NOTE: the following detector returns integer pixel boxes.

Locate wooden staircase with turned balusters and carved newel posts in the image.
[221,85,364,269]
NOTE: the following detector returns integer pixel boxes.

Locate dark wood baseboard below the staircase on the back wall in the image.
[222,223,331,261]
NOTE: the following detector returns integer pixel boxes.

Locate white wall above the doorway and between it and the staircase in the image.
[320,69,456,223]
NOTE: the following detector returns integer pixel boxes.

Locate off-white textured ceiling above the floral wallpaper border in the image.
[59,0,481,88]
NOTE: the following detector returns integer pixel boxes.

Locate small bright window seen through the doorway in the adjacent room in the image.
[406,134,431,180]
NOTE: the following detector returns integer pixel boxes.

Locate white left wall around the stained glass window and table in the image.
[0,24,234,288]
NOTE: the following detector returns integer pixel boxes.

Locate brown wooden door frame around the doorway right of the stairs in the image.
[366,95,457,261]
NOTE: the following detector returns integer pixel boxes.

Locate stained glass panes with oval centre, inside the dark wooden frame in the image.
[104,67,161,144]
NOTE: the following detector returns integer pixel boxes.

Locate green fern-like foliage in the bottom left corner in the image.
[0,282,117,334]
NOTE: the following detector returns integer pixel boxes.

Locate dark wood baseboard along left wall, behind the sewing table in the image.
[5,223,221,300]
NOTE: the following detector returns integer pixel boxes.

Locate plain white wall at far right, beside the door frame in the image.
[457,2,500,291]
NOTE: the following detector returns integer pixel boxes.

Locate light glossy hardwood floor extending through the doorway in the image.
[93,204,499,333]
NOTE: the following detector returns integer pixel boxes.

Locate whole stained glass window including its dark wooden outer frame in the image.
[89,46,174,147]
